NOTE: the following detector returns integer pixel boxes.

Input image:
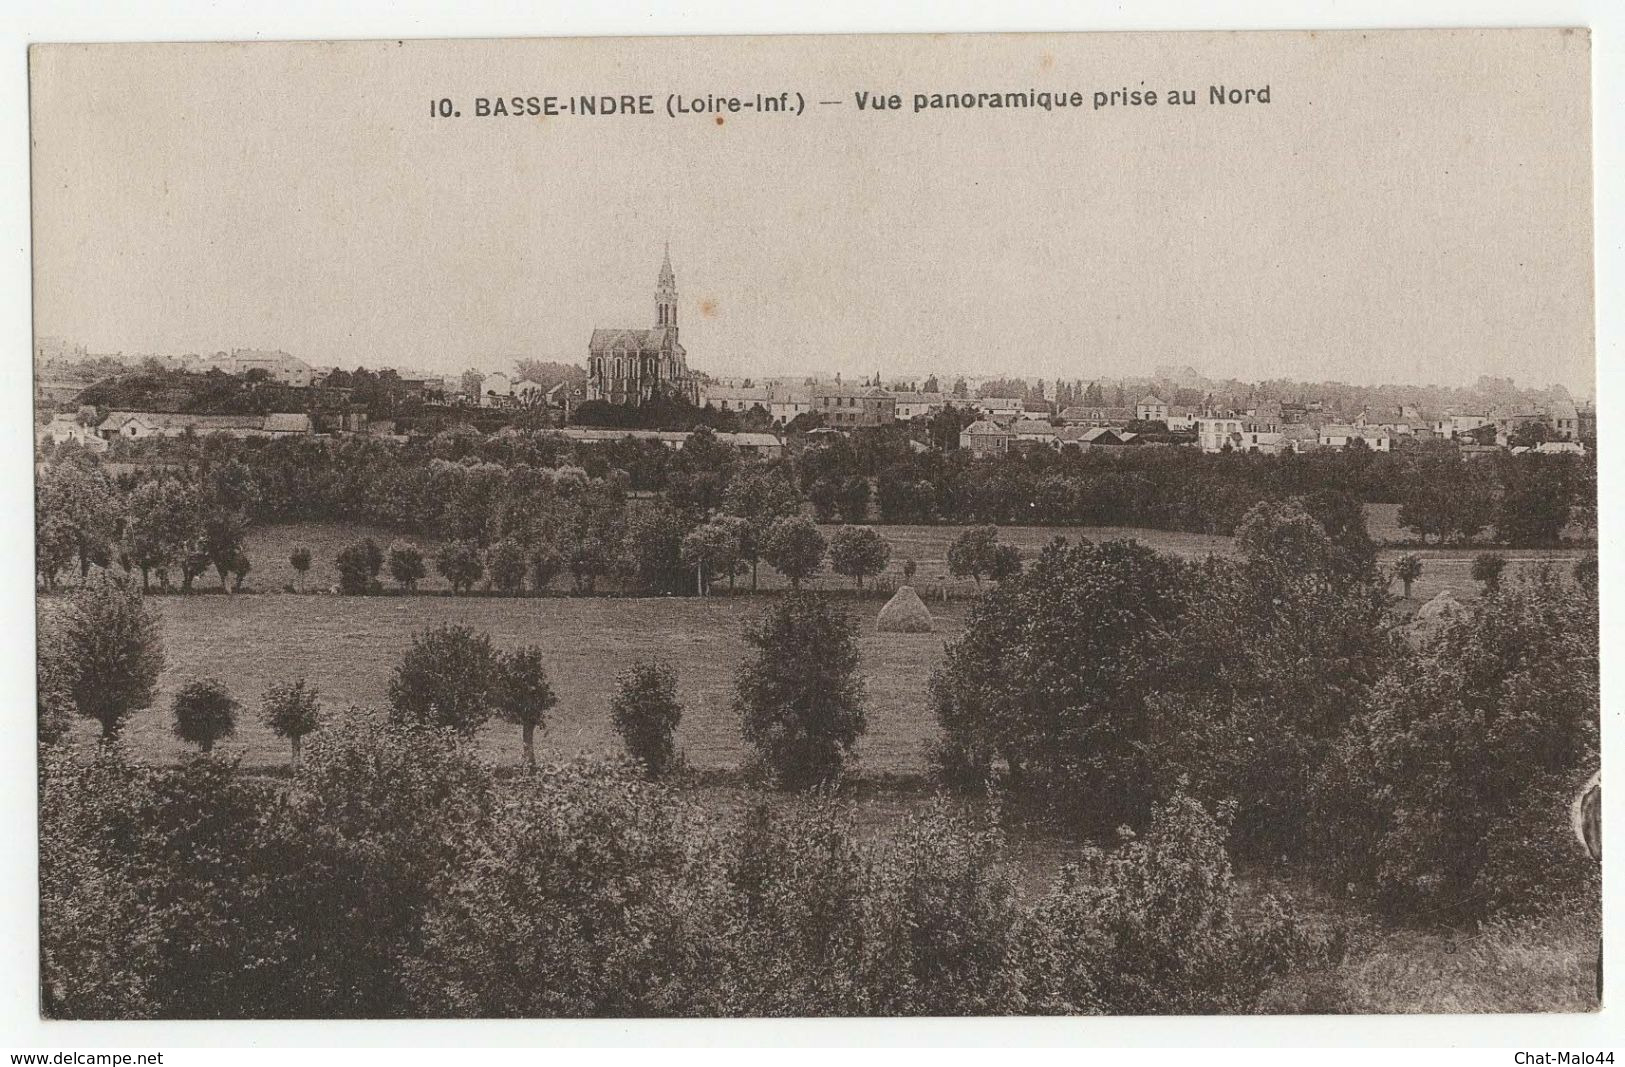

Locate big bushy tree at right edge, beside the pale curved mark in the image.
[1313,568,1601,921]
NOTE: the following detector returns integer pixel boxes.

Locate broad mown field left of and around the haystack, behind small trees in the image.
[63,594,964,773]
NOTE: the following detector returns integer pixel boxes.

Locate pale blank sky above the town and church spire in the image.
[31,31,1594,395]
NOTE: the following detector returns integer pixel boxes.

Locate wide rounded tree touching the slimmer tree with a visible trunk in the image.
[390,624,497,736]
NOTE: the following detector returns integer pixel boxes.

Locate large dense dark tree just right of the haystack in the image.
[931,541,1191,830]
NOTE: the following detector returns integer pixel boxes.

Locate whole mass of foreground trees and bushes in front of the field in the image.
[39,497,1599,1017]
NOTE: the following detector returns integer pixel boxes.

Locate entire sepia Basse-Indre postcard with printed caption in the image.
[29,28,1601,1019]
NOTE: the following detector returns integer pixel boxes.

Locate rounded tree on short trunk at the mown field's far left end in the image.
[62,575,164,739]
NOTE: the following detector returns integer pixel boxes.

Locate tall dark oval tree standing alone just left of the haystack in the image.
[733,594,865,789]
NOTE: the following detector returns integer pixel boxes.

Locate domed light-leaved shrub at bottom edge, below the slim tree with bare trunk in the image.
[406,765,705,1018]
